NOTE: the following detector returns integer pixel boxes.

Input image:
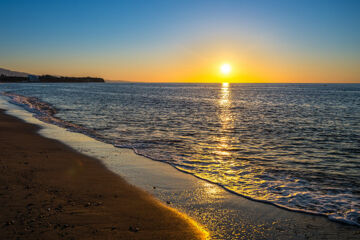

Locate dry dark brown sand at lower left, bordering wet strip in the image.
[0,111,206,240]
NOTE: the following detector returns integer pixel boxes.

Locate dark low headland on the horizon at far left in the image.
[0,68,105,83]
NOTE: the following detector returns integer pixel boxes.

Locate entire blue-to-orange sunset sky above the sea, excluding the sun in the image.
[0,0,360,83]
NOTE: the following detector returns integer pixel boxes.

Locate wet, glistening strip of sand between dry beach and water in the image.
[0,96,360,239]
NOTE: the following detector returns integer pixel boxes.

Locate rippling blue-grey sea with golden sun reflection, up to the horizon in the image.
[0,83,360,226]
